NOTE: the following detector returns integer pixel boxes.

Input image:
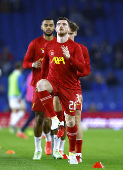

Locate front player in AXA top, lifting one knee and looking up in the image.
[37,17,85,164]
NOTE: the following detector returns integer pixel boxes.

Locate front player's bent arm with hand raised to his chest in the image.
[62,45,85,73]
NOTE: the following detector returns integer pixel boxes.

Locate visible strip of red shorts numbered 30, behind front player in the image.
[76,90,83,111]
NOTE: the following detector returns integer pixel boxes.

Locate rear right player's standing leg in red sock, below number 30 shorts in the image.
[75,110,83,162]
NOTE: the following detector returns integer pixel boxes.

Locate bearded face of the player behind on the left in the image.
[41,20,54,36]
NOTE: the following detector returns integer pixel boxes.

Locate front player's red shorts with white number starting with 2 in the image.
[48,79,76,116]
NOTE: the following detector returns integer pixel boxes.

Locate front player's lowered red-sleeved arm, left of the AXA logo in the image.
[41,46,49,79]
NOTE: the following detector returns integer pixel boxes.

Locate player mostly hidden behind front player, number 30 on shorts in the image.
[68,22,91,162]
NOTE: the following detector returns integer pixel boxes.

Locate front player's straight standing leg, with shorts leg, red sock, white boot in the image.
[59,87,78,164]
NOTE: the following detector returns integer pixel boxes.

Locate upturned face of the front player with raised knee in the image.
[56,20,69,37]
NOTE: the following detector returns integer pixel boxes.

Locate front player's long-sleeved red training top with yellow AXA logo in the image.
[41,39,85,89]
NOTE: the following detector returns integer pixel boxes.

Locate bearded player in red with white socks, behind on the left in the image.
[23,18,56,160]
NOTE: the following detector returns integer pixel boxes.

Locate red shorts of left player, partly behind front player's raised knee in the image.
[31,87,50,117]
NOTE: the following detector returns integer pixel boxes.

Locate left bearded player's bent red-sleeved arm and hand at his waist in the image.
[23,41,41,69]
